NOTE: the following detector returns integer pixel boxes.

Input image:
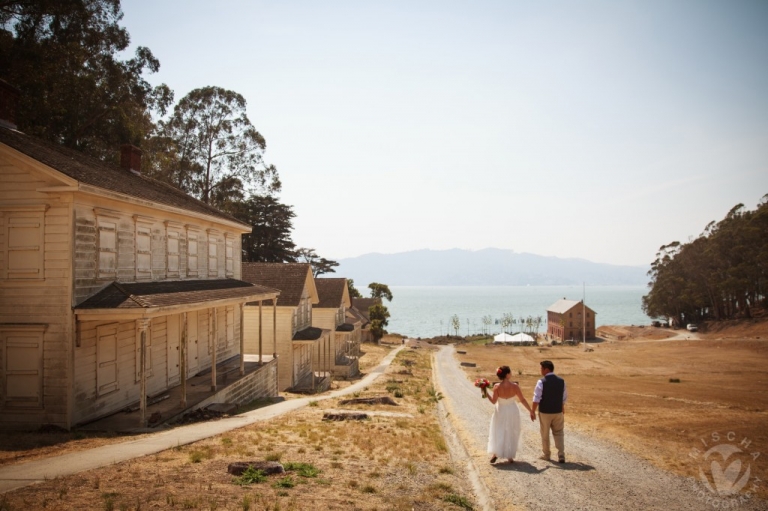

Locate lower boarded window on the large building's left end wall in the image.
[0,325,46,408]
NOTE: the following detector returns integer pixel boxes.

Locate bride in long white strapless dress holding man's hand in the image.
[488,366,531,463]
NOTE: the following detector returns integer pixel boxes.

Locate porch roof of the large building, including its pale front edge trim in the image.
[75,279,280,320]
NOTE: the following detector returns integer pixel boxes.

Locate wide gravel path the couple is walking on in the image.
[435,345,768,511]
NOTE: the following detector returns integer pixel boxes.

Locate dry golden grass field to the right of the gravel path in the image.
[459,321,768,498]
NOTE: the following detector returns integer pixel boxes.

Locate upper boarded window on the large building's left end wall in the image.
[2,205,48,279]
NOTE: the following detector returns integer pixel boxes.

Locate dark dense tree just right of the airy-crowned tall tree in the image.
[235,195,296,263]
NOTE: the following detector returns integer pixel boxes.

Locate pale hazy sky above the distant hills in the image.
[122,0,768,265]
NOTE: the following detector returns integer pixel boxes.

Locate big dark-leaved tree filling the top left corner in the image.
[0,0,173,160]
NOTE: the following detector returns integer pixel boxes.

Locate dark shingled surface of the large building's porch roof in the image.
[75,279,279,311]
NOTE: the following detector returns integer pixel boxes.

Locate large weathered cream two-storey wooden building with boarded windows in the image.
[0,97,279,429]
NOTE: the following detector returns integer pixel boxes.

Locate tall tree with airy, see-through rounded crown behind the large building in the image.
[153,86,281,206]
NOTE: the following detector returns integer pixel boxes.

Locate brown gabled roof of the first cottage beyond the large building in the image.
[237,263,318,307]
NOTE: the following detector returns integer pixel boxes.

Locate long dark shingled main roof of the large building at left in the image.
[0,127,250,227]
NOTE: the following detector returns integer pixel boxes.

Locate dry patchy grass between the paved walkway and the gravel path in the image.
[0,336,472,511]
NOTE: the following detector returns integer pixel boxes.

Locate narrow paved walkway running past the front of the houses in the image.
[0,346,403,494]
